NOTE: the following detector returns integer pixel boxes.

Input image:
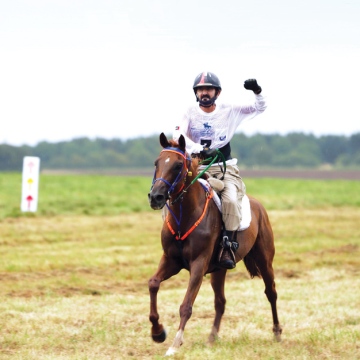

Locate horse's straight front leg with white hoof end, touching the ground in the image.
[166,260,205,356]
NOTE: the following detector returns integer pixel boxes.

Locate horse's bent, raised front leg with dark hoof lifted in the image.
[148,254,181,343]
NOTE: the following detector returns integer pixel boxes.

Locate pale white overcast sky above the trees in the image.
[0,0,360,145]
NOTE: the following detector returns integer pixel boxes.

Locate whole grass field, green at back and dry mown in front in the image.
[0,172,360,360]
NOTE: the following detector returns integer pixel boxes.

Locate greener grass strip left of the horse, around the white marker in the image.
[0,172,152,219]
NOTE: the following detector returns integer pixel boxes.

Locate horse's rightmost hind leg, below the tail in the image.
[249,240,282,341]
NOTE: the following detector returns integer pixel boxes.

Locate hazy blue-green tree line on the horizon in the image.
[0,133,360,171]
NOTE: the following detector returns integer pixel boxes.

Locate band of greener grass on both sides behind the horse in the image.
[0,172,360,220]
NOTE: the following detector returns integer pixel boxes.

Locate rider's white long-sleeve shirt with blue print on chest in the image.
[173,94,267,154]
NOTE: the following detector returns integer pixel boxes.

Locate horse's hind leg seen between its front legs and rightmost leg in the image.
[208,269,226,343]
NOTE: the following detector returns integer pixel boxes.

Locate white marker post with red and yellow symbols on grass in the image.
[21,156,40,212]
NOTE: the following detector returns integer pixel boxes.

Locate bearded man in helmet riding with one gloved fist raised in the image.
[173,72,266,269]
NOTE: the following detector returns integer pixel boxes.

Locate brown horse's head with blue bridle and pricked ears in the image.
[148,133,191,210]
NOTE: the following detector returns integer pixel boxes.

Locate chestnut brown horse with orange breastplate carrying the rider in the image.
[148,133,282,356]
